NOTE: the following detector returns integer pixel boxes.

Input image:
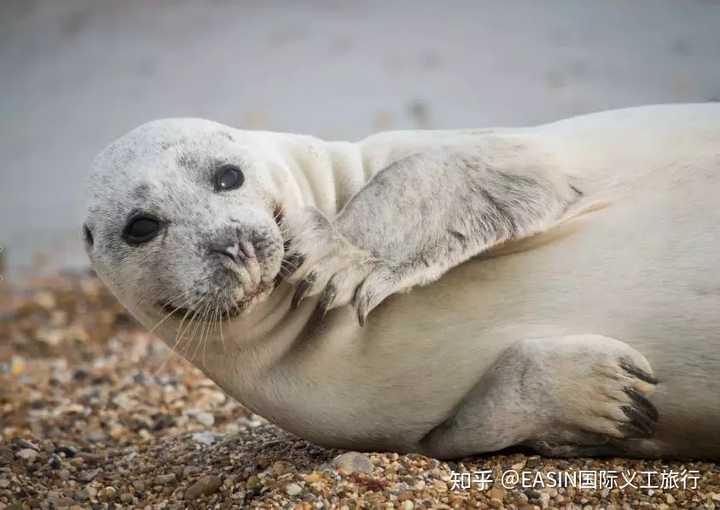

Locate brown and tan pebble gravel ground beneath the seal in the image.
[0,274,720,510]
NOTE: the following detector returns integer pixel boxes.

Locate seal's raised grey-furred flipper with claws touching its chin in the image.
[289,139,582,324]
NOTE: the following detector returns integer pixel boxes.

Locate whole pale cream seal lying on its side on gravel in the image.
[83,104,720,458]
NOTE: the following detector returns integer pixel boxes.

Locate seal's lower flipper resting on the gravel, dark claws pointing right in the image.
[421,335,659,458]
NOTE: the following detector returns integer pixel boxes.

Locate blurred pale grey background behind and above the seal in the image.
[0,0,720,278]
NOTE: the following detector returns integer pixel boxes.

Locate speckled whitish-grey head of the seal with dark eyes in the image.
[83,119,285,330]
